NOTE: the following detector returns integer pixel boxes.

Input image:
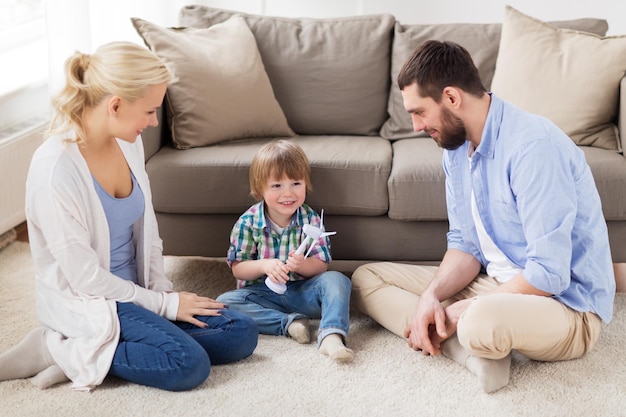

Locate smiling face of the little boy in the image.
[263,176,306,227]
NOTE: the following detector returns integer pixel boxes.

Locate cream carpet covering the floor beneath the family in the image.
[0,242,626,417]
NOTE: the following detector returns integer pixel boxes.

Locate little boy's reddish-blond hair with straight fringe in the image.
[250,139,313,201]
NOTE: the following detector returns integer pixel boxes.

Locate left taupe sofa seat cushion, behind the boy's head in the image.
[146,136,392,216]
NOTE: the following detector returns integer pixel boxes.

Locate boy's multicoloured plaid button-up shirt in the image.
[226,201,331,288]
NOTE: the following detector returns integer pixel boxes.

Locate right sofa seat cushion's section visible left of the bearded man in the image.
[389,138,448,221]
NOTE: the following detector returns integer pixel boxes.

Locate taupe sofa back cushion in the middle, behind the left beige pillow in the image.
[179,5,395,135]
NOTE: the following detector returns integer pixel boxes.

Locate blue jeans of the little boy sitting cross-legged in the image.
[217,271,352,345]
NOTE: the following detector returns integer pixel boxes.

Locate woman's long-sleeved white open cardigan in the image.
[26,135,178,390]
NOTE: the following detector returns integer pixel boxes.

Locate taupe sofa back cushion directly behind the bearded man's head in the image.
[380,18,608,139]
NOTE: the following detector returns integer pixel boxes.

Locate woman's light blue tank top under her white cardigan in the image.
[92,172,145,283]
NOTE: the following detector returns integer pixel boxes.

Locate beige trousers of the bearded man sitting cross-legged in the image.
[352,262,602,361]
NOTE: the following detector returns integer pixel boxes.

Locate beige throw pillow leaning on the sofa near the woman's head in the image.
[132,16,294,149]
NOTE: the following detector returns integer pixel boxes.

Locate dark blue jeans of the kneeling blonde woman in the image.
[109,303,259,391]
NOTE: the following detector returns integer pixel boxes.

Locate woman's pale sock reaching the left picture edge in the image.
[0,327,56,381]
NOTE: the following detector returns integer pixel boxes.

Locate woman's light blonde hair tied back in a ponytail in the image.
[46,42,172,142]
